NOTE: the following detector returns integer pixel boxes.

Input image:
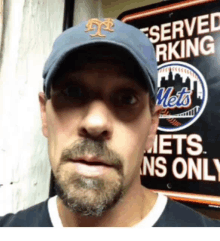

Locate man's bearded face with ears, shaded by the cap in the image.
[40,61,158,216]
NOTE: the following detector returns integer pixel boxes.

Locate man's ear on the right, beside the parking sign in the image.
[145,106,163,151]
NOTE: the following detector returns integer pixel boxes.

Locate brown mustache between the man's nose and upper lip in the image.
[60,139,124,174]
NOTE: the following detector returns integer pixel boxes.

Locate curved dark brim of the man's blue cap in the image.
[44,40,156,101]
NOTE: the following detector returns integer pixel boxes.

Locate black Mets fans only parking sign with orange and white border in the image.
[118,0,220,208]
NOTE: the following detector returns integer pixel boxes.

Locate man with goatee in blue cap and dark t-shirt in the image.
[0,19,220,227]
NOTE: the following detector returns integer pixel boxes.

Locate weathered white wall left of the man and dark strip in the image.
[0,0,64,216]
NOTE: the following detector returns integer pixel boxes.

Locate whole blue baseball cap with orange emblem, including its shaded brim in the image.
[43,18,157,101]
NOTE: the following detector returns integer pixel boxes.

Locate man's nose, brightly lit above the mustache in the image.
[79,101,113,141]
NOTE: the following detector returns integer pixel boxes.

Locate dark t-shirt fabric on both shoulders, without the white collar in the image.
[0,198,220,227]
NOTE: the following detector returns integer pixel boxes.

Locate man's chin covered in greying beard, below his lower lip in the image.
[55,174,123,217]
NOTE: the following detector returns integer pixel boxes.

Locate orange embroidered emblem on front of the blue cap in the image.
[85,18,114,37]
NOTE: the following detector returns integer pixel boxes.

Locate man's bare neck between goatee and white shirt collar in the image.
[57,185,157,227]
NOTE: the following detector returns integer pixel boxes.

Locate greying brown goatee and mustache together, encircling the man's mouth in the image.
[53,139,125,217]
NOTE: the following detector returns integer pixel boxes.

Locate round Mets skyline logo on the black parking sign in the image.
[157,61,208,132]
